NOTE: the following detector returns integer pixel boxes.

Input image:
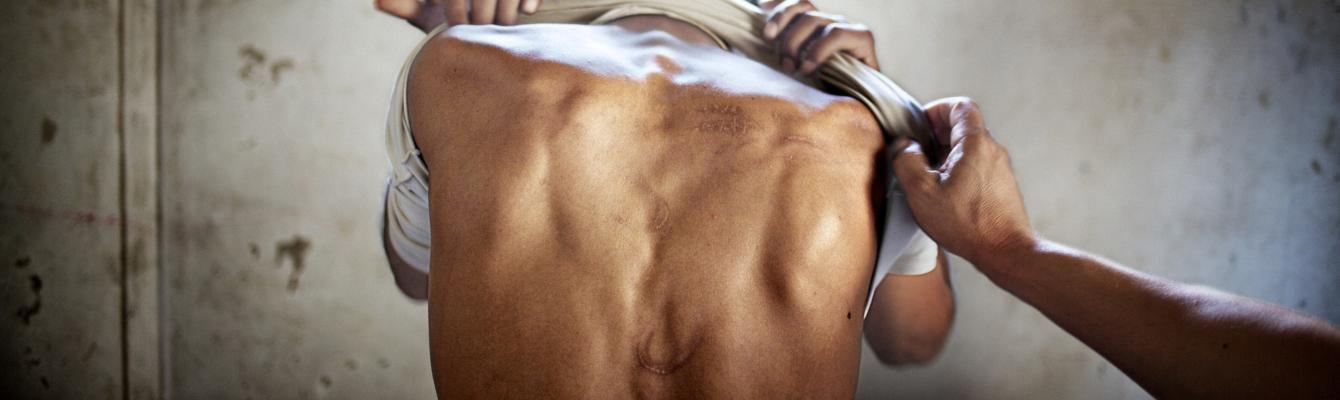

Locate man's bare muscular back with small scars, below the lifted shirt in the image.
[410,25,883,399]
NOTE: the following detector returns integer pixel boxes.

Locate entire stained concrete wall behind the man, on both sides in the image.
[0,0,1340,399]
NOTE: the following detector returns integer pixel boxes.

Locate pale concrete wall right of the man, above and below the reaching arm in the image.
[831,0,1340,399]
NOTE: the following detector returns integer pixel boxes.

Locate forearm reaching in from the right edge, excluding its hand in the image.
[974,241,1340,399]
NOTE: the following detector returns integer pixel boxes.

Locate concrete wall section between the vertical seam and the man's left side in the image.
[161,0,433,399]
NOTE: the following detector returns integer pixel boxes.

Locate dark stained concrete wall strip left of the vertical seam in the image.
[0,0,122,399]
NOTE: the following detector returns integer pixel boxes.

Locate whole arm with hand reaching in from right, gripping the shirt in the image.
[895,99,1340,399]
